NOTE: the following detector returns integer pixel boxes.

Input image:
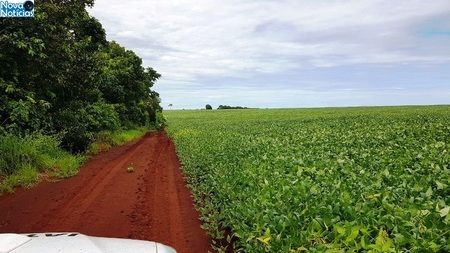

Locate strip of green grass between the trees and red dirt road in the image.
[0,127,151,195]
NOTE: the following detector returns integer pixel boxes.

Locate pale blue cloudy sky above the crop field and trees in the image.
[88,0,450,109]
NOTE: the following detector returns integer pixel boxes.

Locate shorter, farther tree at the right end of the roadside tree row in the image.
[99,41,162,127]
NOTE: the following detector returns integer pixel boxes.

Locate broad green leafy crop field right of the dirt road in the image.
[165,106,450,252]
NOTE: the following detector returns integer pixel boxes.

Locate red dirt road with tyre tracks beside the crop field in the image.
[0,132,212,253]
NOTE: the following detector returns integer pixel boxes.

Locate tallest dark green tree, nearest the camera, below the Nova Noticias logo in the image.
[0,0,106,138]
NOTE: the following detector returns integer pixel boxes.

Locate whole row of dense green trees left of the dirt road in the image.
[0,0,163,153]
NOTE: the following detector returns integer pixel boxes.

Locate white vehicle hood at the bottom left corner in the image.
[0,233,176,253]
